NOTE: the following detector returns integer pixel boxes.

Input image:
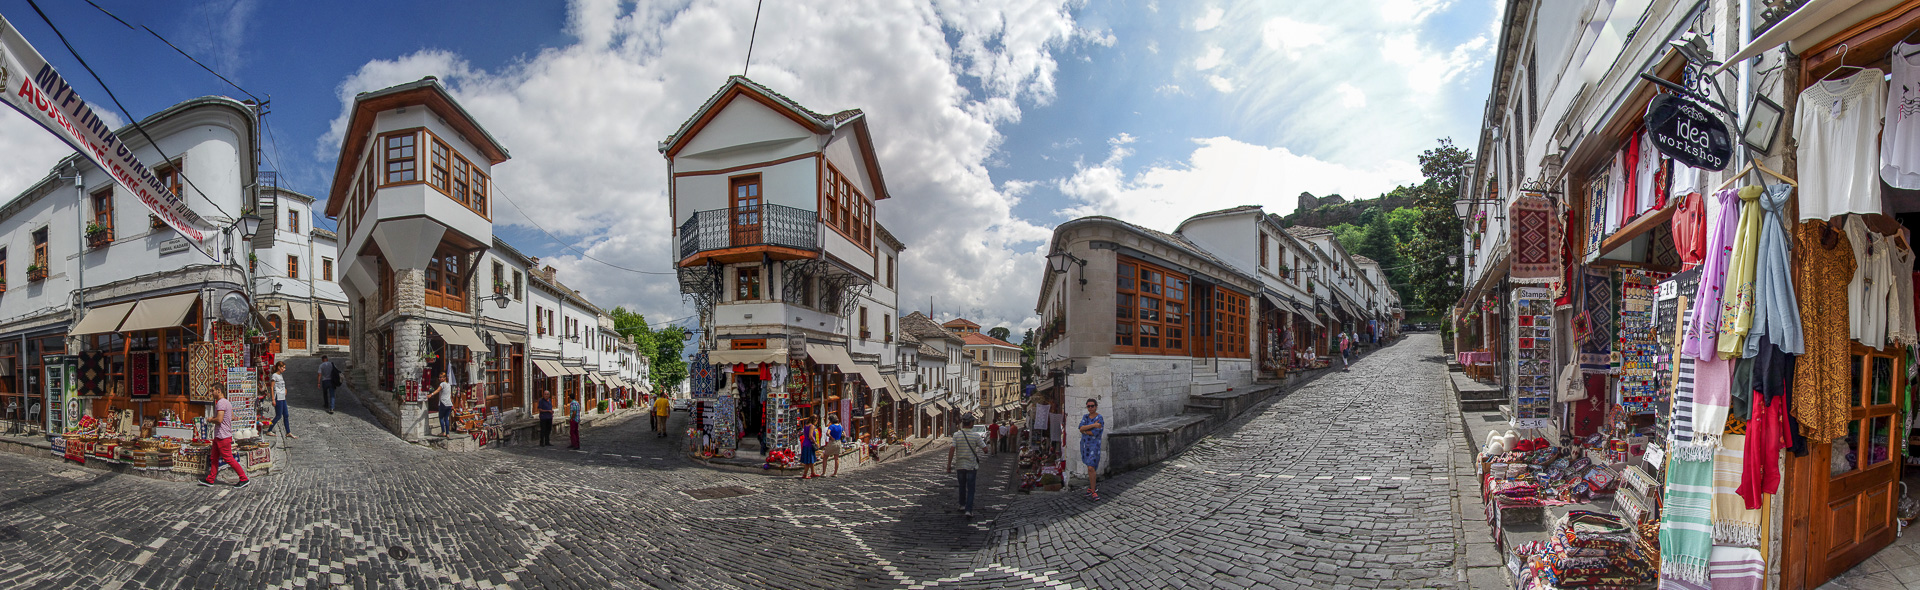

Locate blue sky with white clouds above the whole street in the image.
[0,0,1501,332]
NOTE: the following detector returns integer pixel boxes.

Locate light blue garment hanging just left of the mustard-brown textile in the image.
[1741,183,1807,357]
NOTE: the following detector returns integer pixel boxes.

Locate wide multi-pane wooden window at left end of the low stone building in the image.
[1114,256,1194,356]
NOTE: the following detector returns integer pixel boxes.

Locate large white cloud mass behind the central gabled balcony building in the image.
[317,0,1067,325]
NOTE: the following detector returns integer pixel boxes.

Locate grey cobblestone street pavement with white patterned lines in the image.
[0,336,1453,588]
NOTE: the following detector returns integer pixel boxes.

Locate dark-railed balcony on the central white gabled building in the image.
[680,204,820,267]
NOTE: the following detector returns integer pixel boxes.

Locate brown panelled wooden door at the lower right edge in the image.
[1801,342,1907,588]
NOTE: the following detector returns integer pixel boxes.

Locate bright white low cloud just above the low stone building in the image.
[1056,136,1421,231]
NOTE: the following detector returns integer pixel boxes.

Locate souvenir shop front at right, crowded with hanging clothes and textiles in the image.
[1478,2,1920,590]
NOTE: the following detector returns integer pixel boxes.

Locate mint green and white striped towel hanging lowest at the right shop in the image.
[1661,457,1713,584]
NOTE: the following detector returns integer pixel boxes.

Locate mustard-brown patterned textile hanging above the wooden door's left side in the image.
[1793,219,1855,442]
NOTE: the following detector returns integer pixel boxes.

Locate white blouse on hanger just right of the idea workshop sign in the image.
[1793,67,1887,219]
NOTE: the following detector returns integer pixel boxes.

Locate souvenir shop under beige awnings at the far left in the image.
[43,292,273,477]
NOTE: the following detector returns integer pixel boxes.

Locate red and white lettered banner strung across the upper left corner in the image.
[0,17,221,261]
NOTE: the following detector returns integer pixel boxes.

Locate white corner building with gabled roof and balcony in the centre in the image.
[659,77,918,453]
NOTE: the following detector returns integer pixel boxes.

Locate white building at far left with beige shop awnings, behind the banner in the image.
[0,96,259,430]
